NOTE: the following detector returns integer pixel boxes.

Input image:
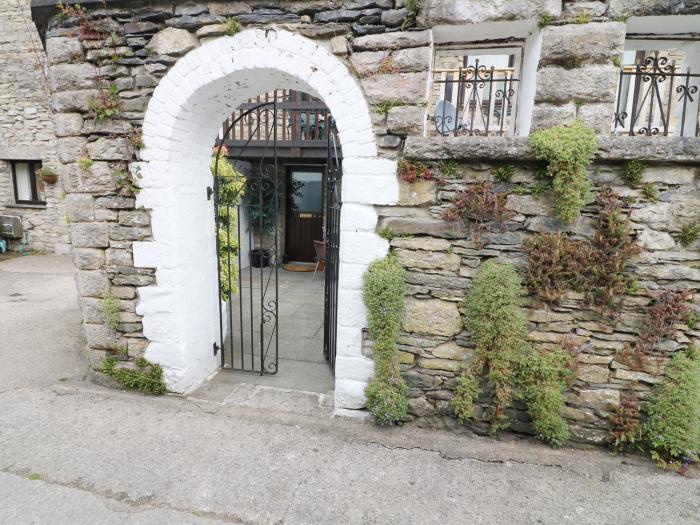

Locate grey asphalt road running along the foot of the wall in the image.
[0,257,700,525]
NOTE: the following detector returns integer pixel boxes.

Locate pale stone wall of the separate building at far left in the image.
[0,0,69,253]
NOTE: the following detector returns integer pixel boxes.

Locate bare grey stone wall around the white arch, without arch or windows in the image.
[34,0,700,443]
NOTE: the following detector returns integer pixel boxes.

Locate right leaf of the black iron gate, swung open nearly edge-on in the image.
[323,119,343,374]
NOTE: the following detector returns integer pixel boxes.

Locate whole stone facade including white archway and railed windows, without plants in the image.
[28,0,700,443]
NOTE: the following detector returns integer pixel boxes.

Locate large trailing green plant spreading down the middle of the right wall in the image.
[453,261,570,446]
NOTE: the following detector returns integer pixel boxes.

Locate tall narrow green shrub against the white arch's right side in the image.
[363,255,408,425]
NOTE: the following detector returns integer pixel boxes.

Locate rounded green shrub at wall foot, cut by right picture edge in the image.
[644,347,700,472]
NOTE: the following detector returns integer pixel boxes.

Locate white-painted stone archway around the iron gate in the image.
[134,29,398,410]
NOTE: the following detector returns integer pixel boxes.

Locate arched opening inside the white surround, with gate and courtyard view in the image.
[210,93,342,393]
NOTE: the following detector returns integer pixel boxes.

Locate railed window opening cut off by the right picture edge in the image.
[613,50,700,137]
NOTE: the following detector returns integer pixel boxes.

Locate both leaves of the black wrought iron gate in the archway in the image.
[208,101,342,375]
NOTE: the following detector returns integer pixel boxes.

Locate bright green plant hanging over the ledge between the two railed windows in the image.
[528,120,598,223]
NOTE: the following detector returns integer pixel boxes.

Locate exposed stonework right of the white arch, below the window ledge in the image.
[380,138,700,443]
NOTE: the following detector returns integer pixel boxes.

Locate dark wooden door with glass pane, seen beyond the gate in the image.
[285,166,323,262]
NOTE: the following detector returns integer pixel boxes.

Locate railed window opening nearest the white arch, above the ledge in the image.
[428,47,522,136]
